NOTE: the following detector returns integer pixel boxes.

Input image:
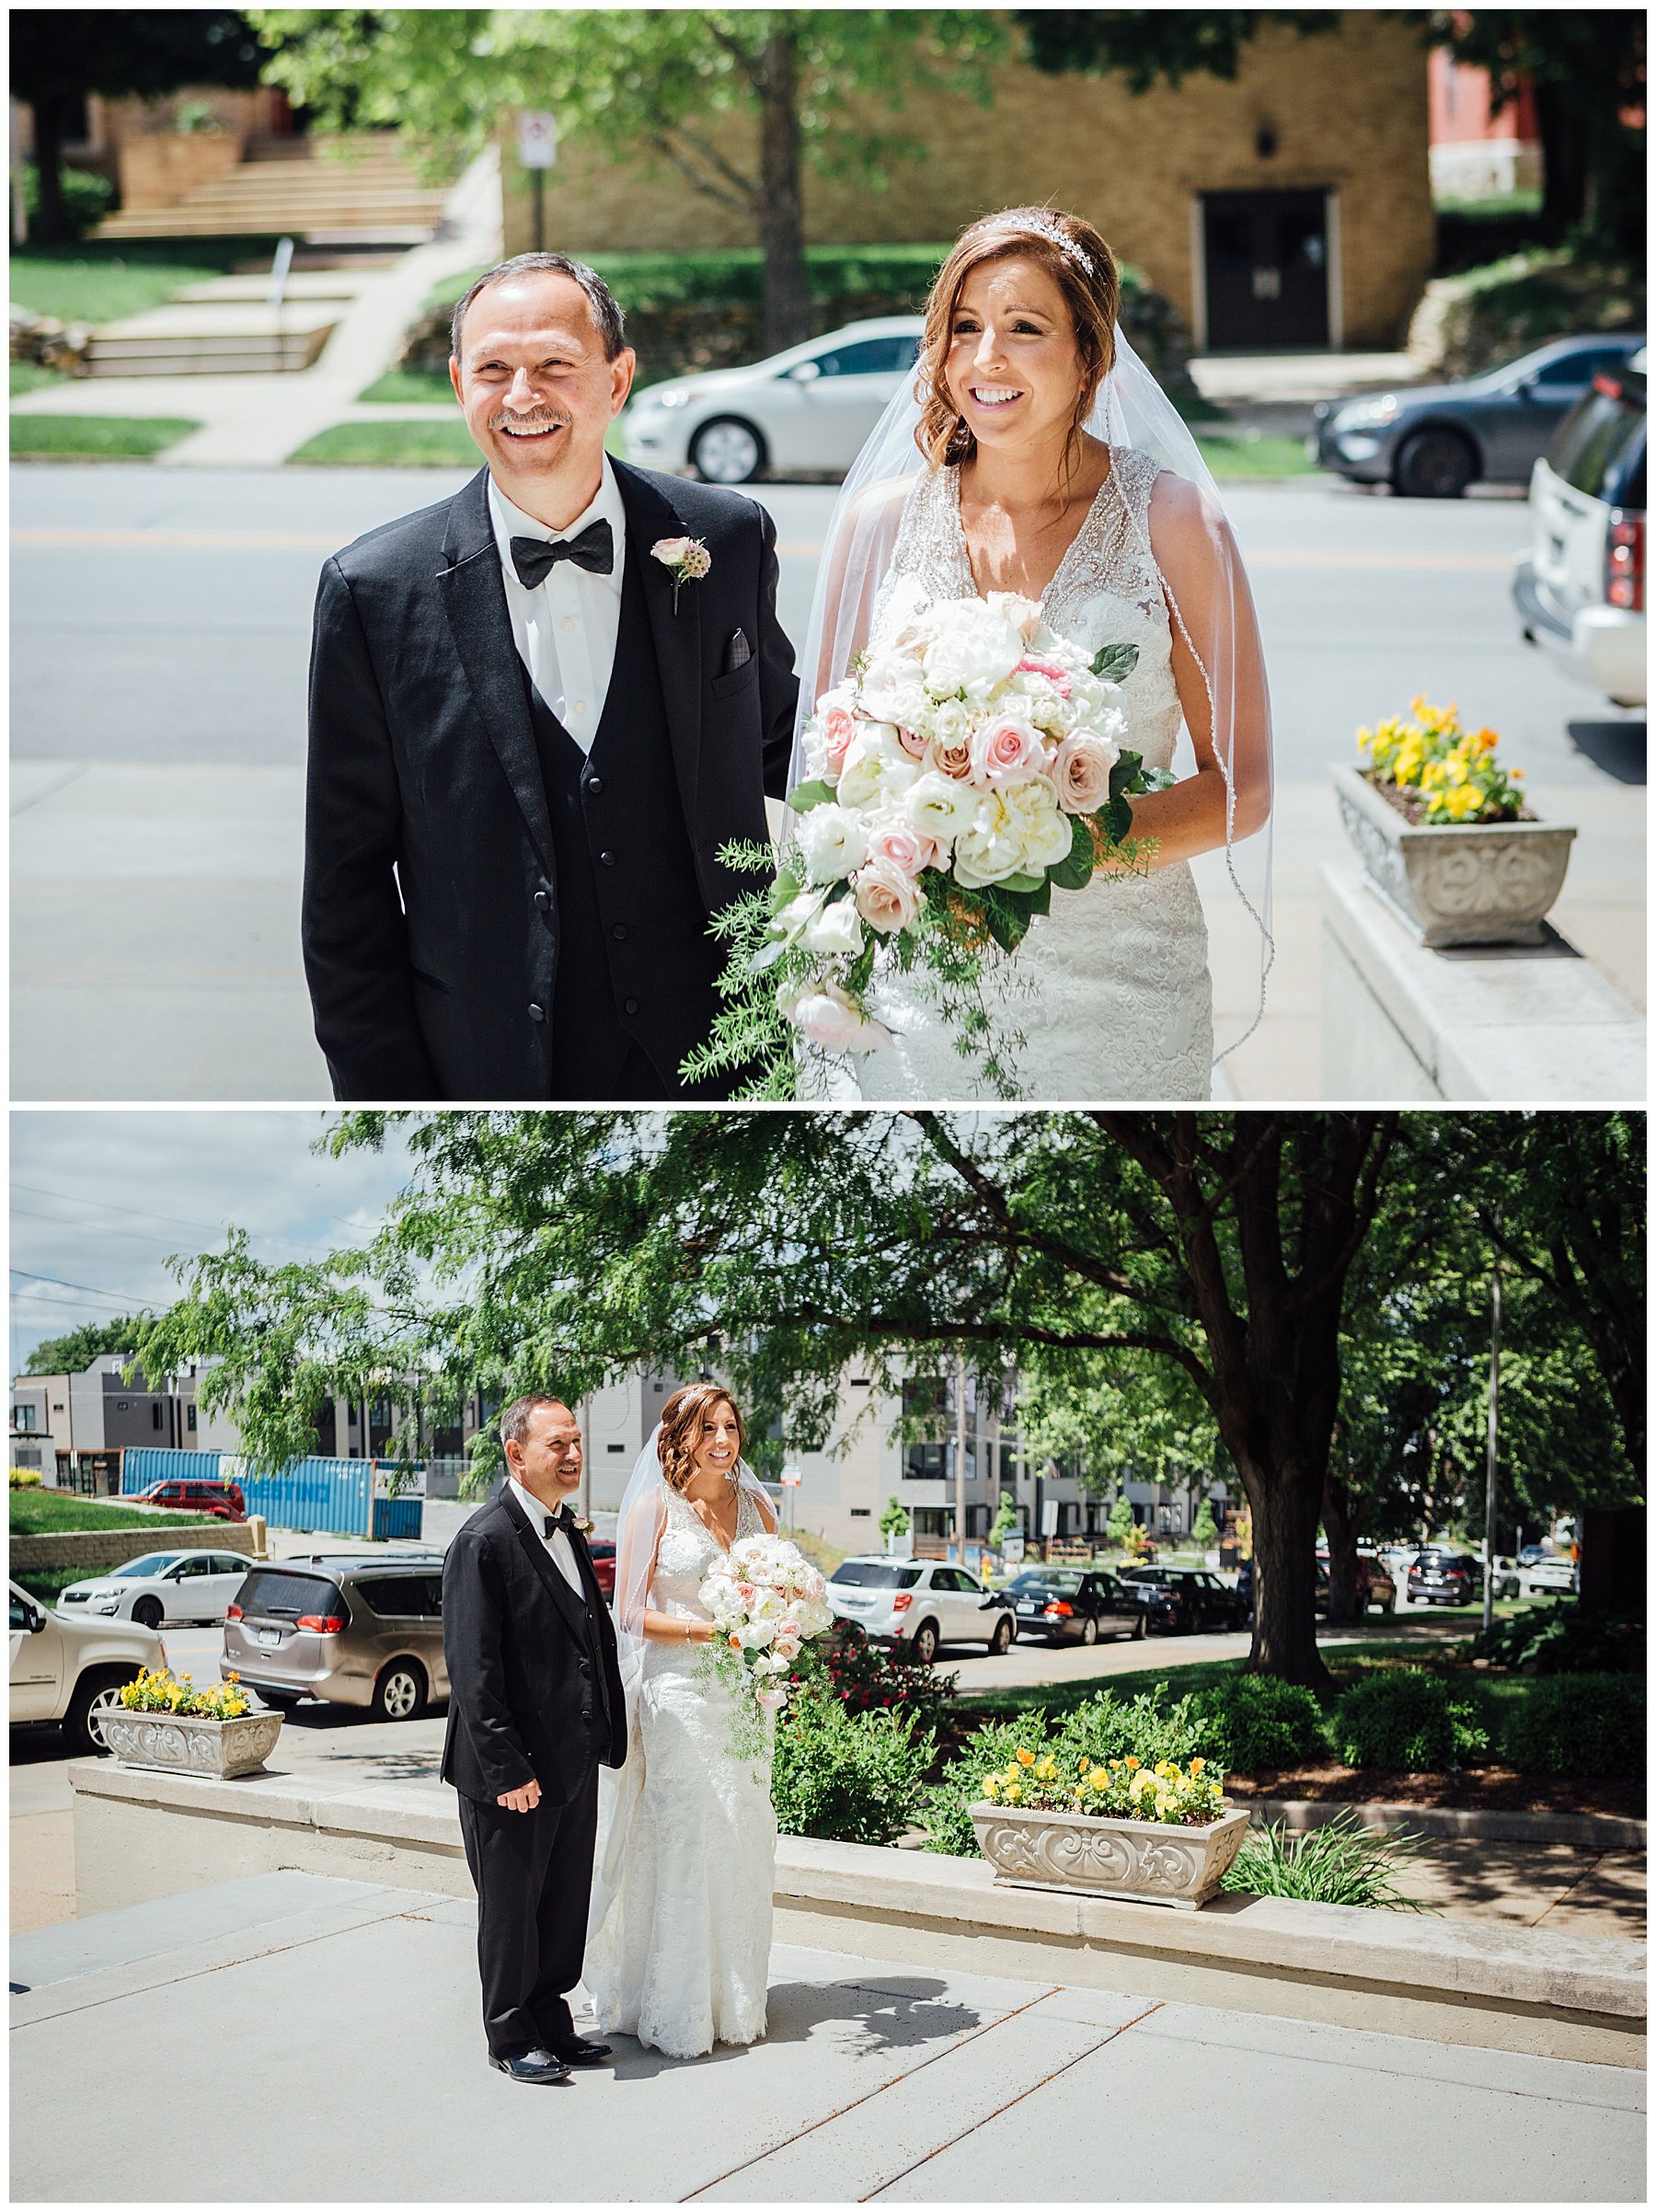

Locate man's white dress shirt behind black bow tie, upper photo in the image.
[489,454,626,752]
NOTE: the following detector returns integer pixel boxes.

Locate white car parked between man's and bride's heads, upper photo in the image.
[621,314,925,484]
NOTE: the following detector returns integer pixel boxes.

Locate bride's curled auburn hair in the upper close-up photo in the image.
[915,208,1121,469]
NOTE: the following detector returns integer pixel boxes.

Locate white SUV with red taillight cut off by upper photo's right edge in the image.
[1512,347,1647,706]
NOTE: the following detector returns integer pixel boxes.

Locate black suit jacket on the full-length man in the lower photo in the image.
[443,1489,626,1805]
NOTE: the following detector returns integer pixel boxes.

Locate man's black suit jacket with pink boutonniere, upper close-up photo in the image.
[303,462,799,1104]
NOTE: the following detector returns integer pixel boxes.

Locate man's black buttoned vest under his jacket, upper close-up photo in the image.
[528,536,725,1100]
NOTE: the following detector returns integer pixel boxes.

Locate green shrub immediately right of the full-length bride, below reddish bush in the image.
[772,1688,937,1843]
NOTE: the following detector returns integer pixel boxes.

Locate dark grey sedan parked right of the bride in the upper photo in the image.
[1311,332,1645,500]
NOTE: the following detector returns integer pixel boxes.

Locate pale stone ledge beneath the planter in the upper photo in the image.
[1317,860,1645,1104]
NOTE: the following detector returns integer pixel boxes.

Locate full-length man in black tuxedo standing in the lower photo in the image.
[443,1391,626,2081]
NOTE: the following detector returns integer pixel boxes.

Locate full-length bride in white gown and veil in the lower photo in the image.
[583,1383,776,2059]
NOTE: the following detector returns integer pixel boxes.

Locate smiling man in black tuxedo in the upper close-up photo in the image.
[303,254,799,1104]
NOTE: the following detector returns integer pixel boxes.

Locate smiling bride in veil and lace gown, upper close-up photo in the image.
[794,208,1271,1100]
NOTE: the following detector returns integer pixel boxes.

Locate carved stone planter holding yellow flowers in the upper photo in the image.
[1333,766,1576,947]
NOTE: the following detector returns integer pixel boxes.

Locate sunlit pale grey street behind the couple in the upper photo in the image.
[11,467,1645,1101]
